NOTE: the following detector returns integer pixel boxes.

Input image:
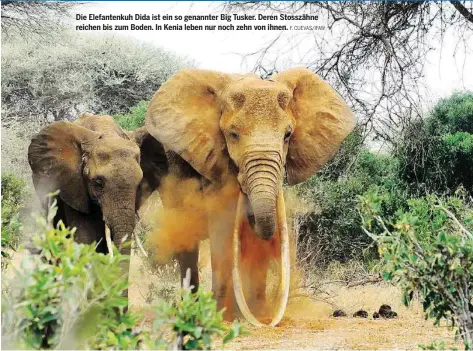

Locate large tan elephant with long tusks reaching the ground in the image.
[146,68,355,325]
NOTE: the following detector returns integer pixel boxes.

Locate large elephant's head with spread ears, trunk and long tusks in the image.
[146,68,355,325]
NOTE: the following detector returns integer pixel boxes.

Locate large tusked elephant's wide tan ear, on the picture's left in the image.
[146,69,234,181]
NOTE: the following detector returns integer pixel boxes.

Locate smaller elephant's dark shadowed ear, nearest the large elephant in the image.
[126,127,168,209]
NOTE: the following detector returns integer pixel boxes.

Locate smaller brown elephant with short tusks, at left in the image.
[28,113,167,297]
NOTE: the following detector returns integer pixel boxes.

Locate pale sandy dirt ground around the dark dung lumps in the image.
[129,245,462,350]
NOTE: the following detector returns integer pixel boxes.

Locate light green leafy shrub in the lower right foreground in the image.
[360,189,473,349]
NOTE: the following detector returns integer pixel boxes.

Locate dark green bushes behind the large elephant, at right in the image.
[292,92,473,266]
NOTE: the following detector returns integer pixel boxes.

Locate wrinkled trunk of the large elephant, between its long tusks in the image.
[244,152,282,240]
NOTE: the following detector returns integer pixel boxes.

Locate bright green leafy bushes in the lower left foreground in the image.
[2,197,240,350]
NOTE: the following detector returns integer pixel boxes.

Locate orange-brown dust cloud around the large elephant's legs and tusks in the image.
[148,176,330,320]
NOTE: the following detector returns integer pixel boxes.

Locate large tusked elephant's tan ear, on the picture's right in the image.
[272,68,356,184]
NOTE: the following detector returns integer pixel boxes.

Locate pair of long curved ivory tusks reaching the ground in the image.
[232,187,290,327]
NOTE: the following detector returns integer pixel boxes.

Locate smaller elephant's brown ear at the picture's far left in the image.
[28,122,100,213]
